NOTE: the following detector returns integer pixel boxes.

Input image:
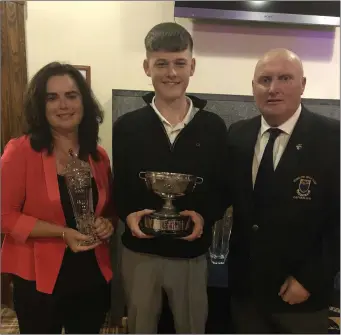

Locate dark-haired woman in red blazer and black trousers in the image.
[1,63,115,334]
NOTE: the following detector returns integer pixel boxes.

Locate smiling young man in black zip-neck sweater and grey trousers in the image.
[113,22,228,334]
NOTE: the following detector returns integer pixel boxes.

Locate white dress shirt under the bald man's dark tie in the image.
[252,105,302,185]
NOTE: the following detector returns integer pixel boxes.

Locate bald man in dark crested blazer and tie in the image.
[224,49,340,333]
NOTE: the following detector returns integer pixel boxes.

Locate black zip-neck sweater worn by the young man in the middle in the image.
[113,94,228,258]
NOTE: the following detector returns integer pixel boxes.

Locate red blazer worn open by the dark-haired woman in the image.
[1,136,113,293]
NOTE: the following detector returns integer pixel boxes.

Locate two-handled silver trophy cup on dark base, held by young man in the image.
[139,171,203,237]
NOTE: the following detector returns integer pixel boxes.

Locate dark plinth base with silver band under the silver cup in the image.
[140,213,193,238]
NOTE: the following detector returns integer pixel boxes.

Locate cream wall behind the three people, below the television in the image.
[26,1,340,157]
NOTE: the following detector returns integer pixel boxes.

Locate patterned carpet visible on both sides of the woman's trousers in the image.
[0,306,127,334]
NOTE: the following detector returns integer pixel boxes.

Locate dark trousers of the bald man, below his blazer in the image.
[231,296,328,334]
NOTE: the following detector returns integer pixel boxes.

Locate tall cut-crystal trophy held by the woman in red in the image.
[62,151,99,245]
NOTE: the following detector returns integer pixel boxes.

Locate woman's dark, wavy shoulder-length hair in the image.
[24,62,103,160]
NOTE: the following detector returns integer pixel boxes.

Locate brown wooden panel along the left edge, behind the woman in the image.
[0,1,27,307]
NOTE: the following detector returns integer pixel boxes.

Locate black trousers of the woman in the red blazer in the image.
[13,276,110,334]
